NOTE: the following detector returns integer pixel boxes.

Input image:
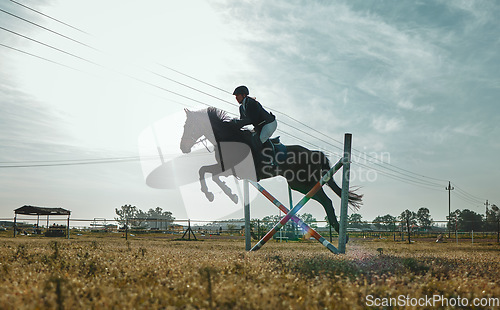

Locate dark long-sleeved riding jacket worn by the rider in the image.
[233,97,276,132]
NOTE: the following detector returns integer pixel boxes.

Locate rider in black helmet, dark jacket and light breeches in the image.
[233,86,278,153]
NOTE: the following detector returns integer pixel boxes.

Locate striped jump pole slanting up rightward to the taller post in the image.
[250,158,344,251]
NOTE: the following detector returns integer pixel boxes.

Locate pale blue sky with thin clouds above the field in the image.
[0,0,500,226]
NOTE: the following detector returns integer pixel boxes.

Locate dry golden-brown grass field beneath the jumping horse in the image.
[0,236,500,309]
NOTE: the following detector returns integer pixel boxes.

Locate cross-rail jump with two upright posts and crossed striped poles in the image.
[244,133,352,254]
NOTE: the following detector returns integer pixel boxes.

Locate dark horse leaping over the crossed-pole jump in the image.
[180,107,363,232]
